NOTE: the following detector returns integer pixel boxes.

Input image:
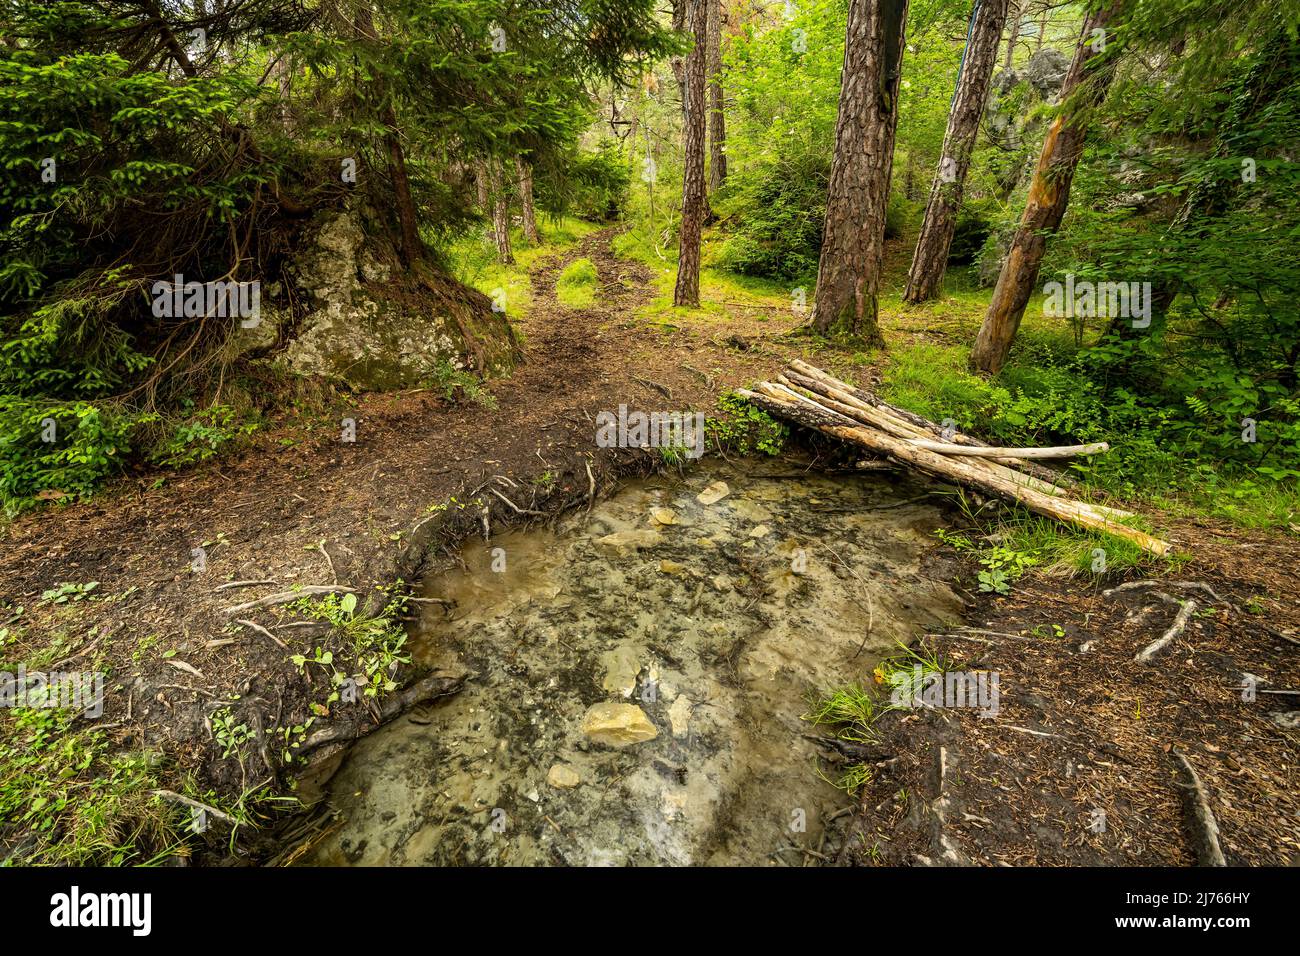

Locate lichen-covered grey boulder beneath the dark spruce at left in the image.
[243,209,517,390]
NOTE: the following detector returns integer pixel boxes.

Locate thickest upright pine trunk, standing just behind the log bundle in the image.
[813,0,907,349]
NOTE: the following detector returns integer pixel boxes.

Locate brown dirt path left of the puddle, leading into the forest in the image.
[0,230,790,832]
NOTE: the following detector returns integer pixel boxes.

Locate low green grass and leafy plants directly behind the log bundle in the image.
[881,329,1300,528]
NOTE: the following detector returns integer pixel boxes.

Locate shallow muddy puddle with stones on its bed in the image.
[303,463,961,865]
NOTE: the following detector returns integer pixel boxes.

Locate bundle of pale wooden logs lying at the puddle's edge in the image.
[738,360,1169,555]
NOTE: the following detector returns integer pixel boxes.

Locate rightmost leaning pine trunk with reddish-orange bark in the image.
[971,3,1122,375]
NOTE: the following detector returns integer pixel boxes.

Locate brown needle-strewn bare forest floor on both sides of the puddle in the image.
[0,229,1300,865]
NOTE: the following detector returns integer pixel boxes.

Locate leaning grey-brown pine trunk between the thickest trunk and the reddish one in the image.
[904,0,1008,303]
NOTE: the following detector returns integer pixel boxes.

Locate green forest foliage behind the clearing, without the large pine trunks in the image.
[0,0,1300,528]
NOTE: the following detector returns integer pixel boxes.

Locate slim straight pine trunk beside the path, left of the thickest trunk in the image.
[672,0,709,307]
